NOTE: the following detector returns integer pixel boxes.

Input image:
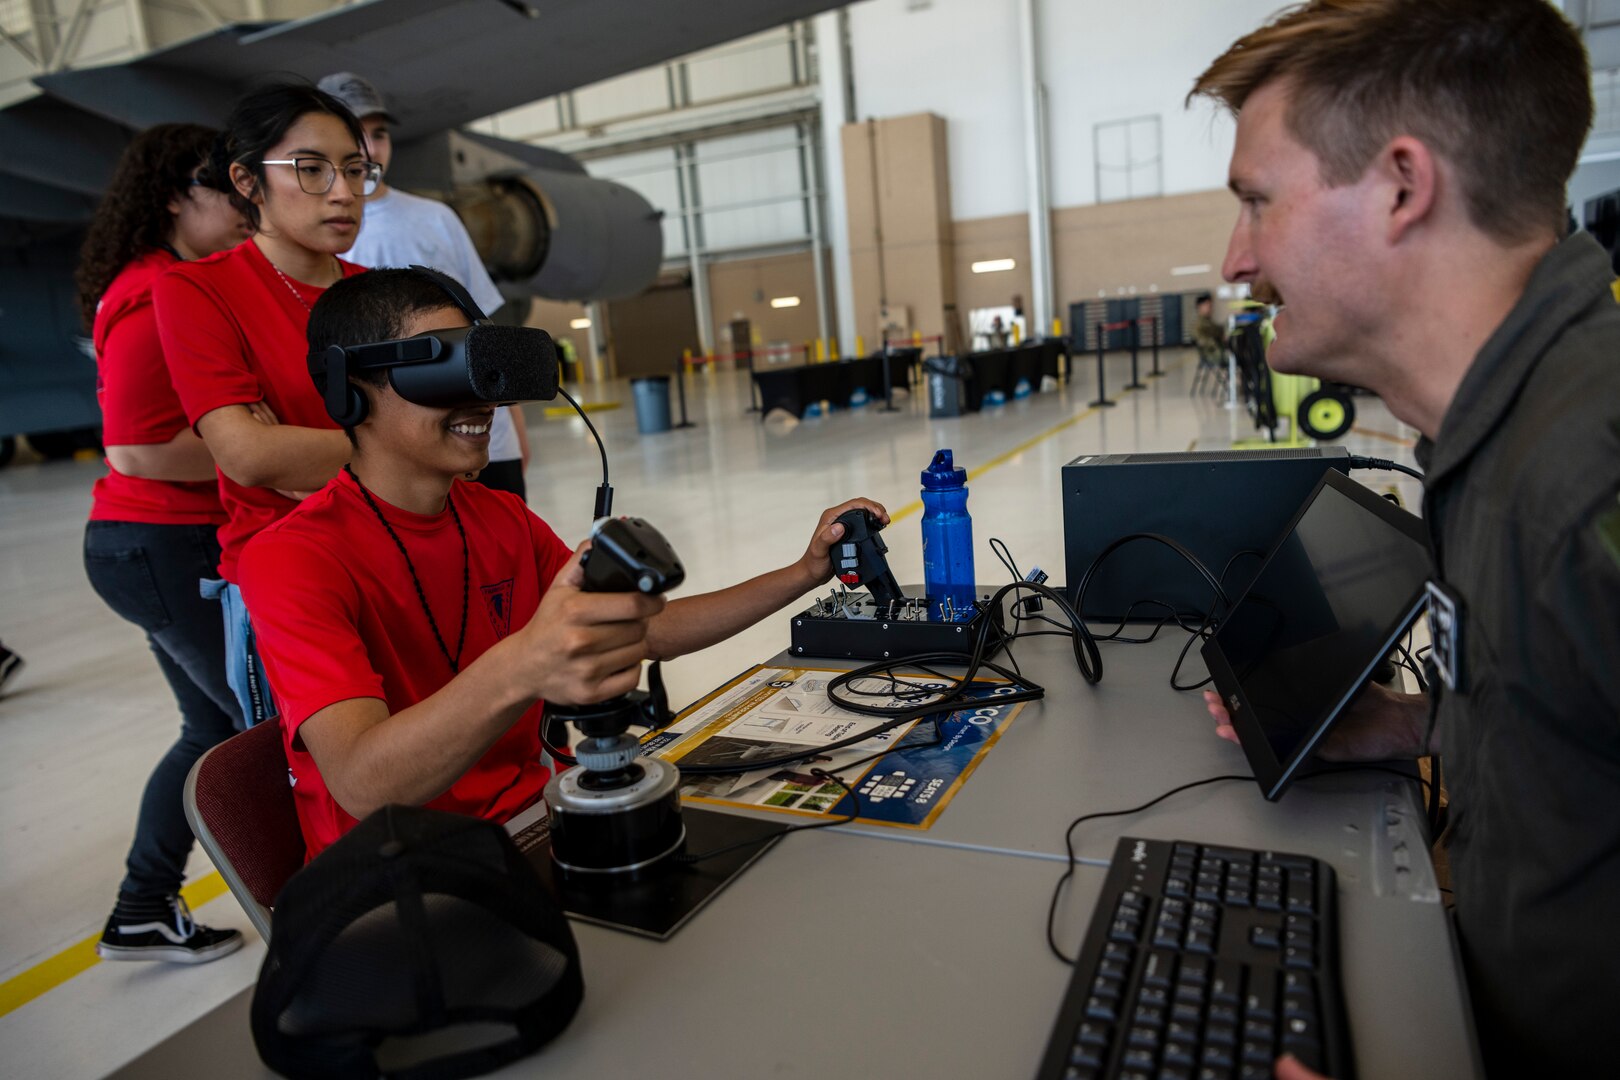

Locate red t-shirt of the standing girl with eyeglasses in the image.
[152,240,365,581]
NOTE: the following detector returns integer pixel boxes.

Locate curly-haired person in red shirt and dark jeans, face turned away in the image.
[75,123,253,963]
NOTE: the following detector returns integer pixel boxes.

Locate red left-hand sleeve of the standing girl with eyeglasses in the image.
[152,267,264,427]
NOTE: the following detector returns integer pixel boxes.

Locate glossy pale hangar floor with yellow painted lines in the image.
[0,353,1418,1078]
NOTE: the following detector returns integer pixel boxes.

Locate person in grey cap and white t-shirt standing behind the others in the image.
[318,71,528,499]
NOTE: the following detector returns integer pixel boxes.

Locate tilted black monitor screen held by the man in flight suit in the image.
[1204,471,1430,800]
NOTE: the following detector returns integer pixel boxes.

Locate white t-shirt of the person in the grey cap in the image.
[343,188,522,461]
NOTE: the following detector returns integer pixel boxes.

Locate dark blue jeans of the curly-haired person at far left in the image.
[84,521,241,897]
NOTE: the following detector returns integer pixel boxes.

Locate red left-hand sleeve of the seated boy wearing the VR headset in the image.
[238,529,387,738]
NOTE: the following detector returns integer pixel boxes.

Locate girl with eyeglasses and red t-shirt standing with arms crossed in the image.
[154,83,381,725]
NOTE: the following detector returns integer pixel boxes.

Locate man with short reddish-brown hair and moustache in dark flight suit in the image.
[1192,0,1620,1080]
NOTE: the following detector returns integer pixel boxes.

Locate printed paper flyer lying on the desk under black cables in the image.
[643,665,1022,829]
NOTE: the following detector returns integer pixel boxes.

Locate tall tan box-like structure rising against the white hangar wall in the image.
[841,113,956,350]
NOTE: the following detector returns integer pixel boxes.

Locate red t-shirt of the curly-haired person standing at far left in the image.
[91,249,225,525]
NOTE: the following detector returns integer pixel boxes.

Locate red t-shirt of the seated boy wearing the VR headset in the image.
[240,471,572,858]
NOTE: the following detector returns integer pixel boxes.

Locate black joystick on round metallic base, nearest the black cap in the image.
[546,518,685,874]
